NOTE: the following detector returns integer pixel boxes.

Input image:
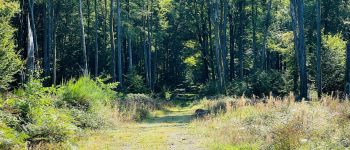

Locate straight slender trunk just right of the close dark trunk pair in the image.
[316,0,322,99]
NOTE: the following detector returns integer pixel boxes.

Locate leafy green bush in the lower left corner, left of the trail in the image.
[0,79,76,146]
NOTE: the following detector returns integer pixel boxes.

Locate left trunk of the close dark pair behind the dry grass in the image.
[290,0,300,95]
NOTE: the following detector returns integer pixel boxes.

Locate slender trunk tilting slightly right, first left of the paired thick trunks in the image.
[261,0,272,70]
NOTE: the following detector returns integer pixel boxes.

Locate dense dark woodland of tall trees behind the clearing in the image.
[1,0,350,98]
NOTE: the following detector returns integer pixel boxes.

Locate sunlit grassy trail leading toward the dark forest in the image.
[78,107,206,150]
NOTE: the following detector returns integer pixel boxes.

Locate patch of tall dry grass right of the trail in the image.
[192,96,350,149]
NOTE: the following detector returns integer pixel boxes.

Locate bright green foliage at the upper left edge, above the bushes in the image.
[0,0,22,90]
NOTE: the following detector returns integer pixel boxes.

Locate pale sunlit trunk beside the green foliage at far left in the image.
[27,15,35,77]
